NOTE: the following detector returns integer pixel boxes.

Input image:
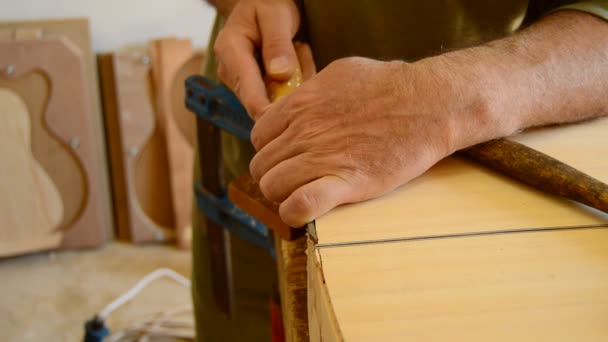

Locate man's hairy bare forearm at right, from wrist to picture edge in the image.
[422,10,608,149]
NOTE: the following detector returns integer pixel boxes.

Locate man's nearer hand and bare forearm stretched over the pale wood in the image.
[250,11,608,227]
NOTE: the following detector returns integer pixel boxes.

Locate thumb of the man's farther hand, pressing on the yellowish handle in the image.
[258,1,300,81]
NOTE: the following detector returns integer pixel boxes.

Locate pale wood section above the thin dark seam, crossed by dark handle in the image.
[316,118,608,245]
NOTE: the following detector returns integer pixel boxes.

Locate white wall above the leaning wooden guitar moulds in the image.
[0,0,215,52]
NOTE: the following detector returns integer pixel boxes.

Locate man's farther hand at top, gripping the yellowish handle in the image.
[214,0,314,119]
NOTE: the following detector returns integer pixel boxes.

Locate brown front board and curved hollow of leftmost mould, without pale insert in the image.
[0,38,109,252]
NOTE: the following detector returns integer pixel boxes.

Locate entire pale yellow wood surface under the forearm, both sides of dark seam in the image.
[307,118,608,342]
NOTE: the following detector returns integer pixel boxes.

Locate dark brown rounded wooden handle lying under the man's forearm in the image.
[461,139,608,213]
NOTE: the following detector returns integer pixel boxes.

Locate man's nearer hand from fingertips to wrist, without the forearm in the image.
[250,58,510,227]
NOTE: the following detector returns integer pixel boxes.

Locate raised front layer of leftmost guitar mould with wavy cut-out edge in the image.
[0,37,111,247]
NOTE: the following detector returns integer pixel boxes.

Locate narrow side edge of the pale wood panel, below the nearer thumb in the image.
[306,238,344,342]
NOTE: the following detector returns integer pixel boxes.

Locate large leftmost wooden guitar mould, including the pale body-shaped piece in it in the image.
[0,20,112,255]
